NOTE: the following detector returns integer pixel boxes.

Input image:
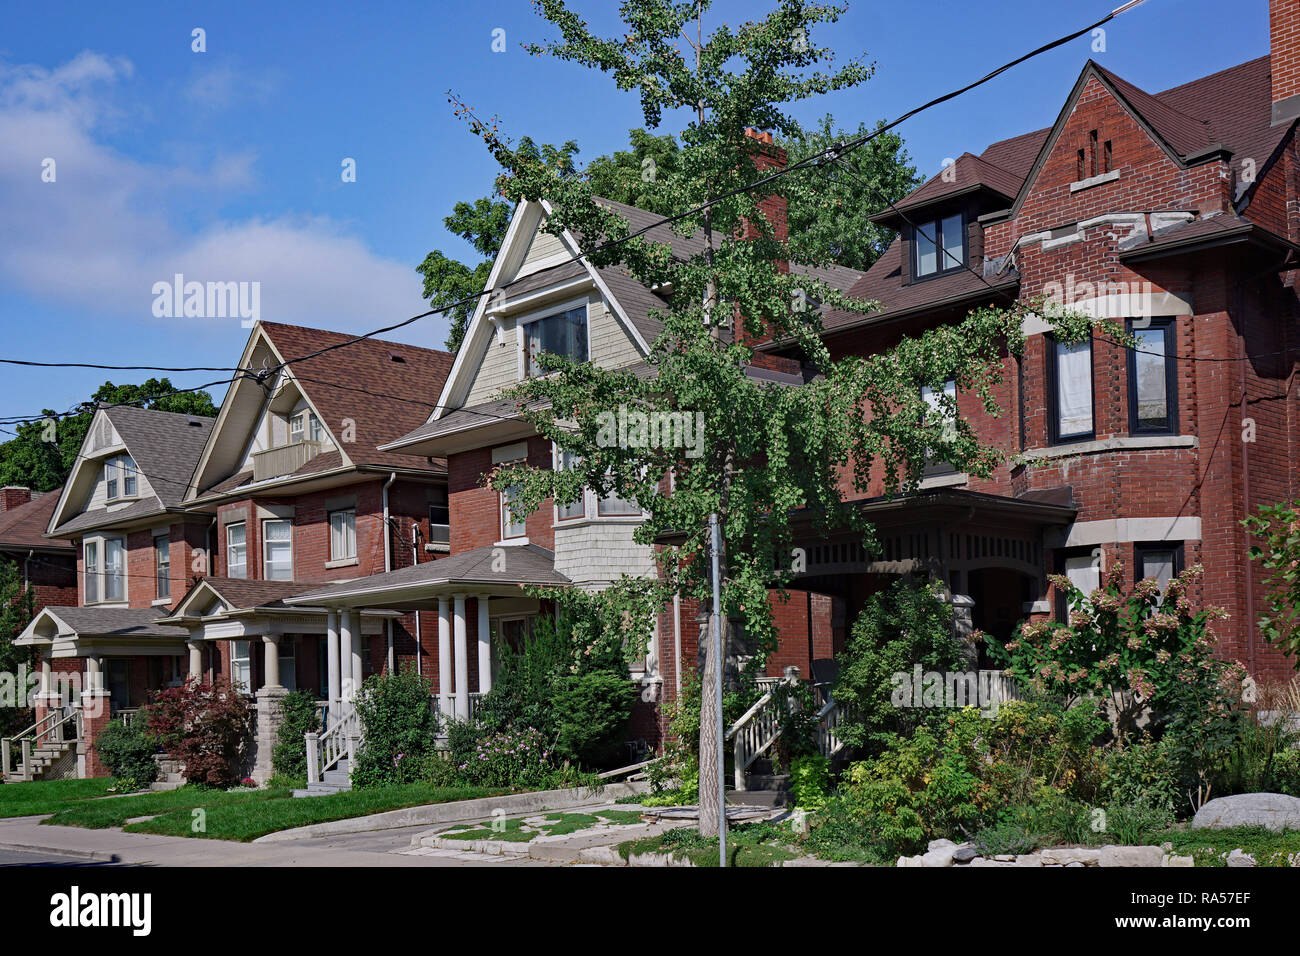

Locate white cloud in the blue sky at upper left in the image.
[0,53,424,340]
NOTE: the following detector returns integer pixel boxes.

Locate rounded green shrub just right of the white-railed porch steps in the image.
[352,667,438,788]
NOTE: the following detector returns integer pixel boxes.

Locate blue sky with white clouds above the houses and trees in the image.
[0,0,1268,426]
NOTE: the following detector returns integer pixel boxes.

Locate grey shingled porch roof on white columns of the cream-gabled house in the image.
[285,545,571,606]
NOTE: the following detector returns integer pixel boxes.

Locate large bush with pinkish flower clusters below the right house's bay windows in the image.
[987,562,1245,735]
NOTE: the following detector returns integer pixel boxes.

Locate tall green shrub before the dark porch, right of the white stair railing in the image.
[833,580,967,753]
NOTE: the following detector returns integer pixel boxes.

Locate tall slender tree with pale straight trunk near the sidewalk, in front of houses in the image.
[464,0,1087,835]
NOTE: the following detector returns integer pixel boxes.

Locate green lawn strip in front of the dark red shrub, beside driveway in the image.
[122,783,506,843]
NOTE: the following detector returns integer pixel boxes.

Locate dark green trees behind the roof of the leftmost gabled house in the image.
[0,378,217,492]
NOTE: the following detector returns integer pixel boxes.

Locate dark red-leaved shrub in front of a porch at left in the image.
[144,678,252,787]
